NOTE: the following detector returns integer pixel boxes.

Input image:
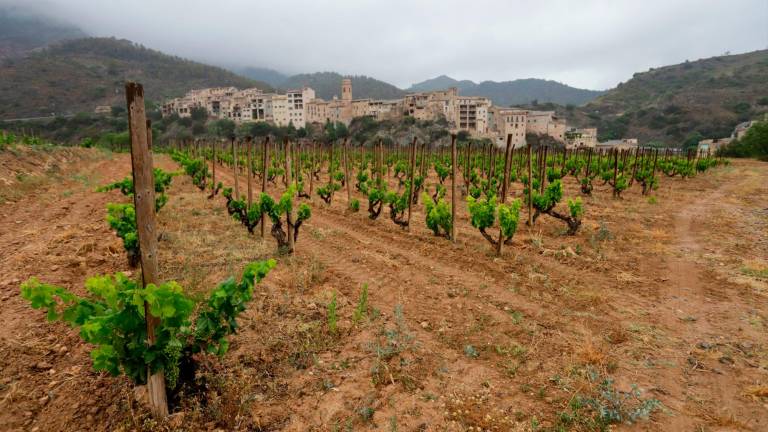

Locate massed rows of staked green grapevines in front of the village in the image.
[169,130,727,253]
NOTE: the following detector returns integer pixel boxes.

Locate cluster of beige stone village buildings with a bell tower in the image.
[162,79,608,149]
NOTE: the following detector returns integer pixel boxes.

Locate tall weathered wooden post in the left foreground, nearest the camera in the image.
[125,82,168,418]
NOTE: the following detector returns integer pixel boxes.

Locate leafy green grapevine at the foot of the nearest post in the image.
[21,260,275,389]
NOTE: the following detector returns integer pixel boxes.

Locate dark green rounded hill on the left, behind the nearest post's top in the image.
[0,38,272,118]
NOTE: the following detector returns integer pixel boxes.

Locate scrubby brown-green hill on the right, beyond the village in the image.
[571,50,768,143]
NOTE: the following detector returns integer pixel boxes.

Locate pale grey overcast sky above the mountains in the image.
[6,0,768,89]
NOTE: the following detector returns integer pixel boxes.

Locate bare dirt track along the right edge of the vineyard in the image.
[640,164,768,430]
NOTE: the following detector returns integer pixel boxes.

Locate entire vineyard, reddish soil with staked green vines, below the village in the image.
[0,82,768,431]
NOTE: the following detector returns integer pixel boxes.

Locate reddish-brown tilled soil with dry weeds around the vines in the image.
[0,150,768,431]
